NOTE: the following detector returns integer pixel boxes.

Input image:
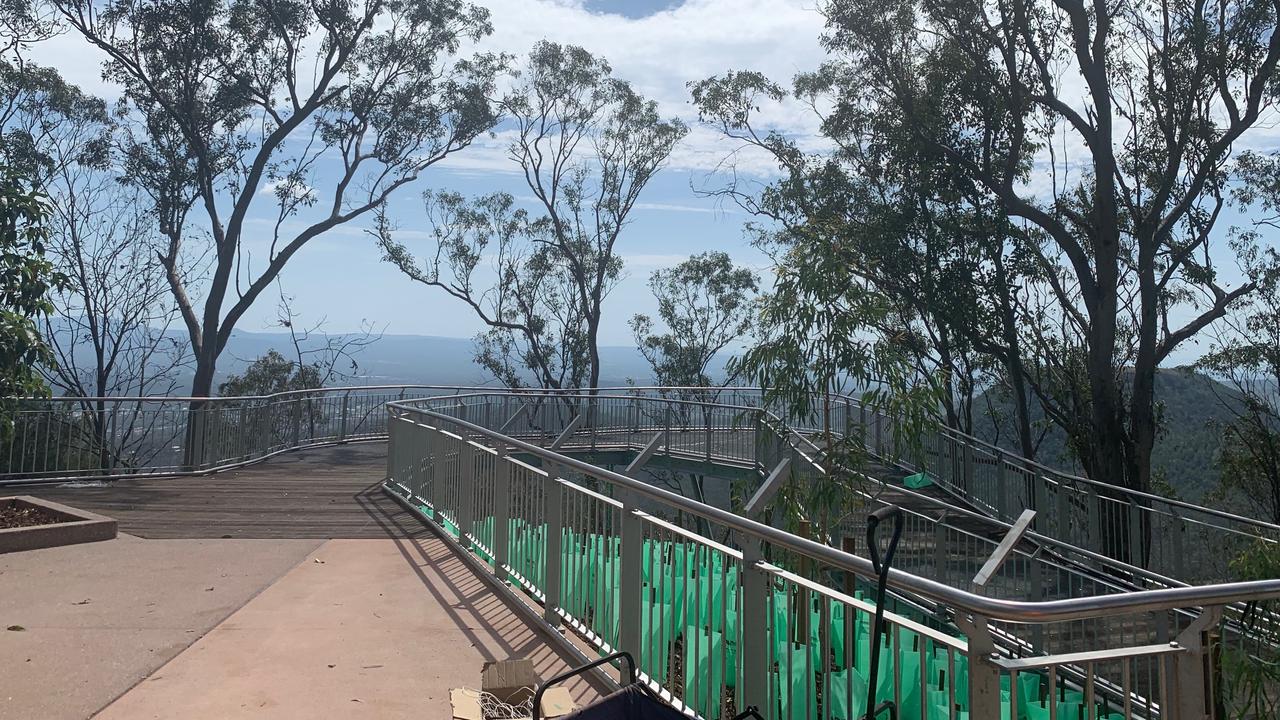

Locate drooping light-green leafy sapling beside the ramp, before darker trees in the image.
[731,227,938,533]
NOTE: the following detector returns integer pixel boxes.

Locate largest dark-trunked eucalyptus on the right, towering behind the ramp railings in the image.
[819,0,1280,520]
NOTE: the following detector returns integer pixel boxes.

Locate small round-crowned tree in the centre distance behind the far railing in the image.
[631,252,759,387]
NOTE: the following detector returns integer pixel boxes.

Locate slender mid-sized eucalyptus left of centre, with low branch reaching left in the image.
[376,41,686,388]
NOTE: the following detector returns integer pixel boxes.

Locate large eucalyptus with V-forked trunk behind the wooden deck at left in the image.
[52,0,500,407]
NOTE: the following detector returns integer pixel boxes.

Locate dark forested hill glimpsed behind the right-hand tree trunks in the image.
[974,368,1235,502]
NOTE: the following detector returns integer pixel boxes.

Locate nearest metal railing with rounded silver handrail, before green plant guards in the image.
[388,393,1280,717]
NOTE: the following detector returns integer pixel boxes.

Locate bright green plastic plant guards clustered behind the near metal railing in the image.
[421,499,1123,720]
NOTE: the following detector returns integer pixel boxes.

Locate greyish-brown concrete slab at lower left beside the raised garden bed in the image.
[0,534,320,720]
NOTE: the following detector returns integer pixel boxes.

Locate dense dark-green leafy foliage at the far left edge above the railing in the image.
[0,169,63,398]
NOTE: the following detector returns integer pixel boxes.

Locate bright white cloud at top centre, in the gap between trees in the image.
[465,0,824,177]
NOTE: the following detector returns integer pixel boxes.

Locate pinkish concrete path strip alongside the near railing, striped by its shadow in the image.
[97,537,596,720]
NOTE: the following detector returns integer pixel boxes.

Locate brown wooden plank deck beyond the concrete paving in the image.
[23,442,429,538]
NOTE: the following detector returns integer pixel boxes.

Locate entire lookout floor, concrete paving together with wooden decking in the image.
[0,443,598,720]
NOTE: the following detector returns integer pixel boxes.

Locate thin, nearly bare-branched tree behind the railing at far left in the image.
[0,64,188,399]
